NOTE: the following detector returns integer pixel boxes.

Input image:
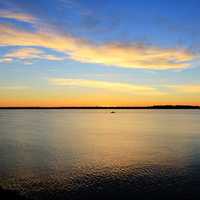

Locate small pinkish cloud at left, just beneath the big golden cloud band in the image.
[2,47,64,62]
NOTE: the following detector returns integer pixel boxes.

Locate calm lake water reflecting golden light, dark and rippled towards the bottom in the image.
[0,110,200,199]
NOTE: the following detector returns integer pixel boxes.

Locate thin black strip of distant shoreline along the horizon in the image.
[0,105,200,110]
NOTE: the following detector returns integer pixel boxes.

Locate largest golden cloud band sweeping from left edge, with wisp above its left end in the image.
[0,10,195,70]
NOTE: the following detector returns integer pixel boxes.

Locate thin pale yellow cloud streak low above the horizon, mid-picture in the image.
[48,78,162,95]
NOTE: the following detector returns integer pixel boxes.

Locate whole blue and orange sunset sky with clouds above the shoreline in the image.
[0,0,200,106]
